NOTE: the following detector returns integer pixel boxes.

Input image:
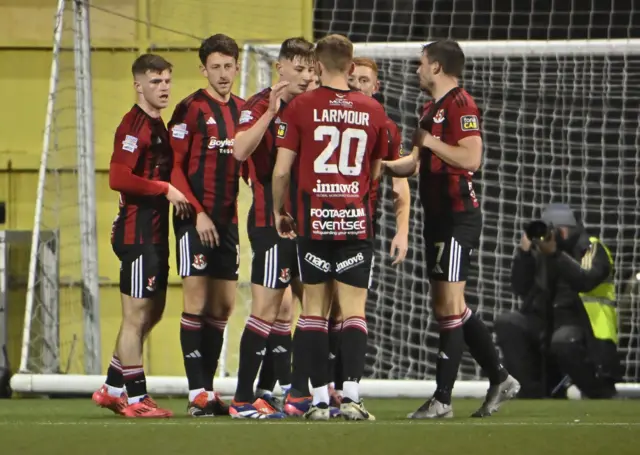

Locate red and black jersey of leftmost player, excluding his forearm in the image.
[110,105,173,245]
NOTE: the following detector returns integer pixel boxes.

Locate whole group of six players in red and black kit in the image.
[93,34,519,420]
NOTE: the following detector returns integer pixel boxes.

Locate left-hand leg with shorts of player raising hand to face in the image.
[230,228,291,419]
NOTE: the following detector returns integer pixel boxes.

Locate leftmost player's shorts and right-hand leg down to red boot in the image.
[117,246,173,417]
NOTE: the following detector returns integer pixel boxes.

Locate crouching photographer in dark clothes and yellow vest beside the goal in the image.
[495,204,620,398]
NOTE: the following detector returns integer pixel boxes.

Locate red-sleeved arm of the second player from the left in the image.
[169,103,204,214]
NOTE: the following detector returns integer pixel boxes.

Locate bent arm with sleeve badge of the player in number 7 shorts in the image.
[417,103,482,172]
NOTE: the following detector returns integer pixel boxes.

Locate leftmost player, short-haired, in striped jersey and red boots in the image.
[93,54,189,417]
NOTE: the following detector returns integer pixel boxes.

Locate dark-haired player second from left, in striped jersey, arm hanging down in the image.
[169,34,244,417]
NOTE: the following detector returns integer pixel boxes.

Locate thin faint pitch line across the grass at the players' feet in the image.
[0,419,640,427]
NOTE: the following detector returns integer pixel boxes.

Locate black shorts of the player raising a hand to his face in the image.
[249,227,299,289]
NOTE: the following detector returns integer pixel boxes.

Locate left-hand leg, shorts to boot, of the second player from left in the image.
[175,223,212,417]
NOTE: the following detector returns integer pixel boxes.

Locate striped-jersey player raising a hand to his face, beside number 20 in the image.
[231,37,314,418]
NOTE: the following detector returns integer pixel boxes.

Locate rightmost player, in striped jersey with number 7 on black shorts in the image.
[383,40,519,419]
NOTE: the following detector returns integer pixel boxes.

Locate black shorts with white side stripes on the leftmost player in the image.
[112,245,169,299]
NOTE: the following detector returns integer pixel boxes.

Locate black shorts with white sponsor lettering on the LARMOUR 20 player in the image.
[298,237,373,289]
